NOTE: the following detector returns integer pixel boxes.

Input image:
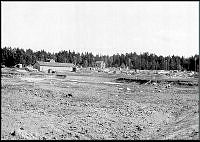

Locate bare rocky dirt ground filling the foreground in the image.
[1,70,199,140]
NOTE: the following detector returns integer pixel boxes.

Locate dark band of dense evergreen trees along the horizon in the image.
[1,47,199,71]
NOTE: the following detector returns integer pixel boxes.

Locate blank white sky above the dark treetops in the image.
[1,1,199,57]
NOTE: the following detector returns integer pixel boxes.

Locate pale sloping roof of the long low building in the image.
[37,61,74,67]
